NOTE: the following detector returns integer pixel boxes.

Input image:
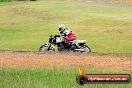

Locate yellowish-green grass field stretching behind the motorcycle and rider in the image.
[0,0,132,53]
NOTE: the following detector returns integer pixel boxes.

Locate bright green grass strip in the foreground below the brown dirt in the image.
[0,67,132,88]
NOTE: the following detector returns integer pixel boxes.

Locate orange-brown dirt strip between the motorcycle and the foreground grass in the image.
[0,52,132,71]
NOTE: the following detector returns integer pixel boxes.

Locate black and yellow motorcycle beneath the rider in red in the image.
[39,35,91,53]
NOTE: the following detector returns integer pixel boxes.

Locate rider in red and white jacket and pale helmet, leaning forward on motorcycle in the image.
[59,24,76,49]
